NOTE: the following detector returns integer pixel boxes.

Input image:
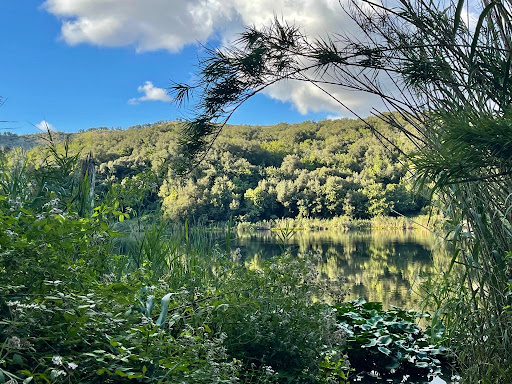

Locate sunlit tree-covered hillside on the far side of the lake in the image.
[5,115,425,221]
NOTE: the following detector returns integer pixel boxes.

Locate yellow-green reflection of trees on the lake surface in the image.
[236,231,450,308]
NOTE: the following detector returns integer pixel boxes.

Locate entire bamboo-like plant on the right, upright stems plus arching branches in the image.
[173,0,512,383]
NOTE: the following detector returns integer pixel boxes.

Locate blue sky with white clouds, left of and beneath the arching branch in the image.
[0,0,380,134]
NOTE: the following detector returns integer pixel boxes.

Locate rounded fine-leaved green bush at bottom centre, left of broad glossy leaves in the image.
[213,255,344,383]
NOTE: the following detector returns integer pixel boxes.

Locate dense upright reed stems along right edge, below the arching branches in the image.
[415,118,512,383]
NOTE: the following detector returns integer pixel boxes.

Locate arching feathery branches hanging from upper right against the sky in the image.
[172,0,511,185]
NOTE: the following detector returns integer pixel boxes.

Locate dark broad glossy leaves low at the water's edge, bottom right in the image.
[336,299,447,382]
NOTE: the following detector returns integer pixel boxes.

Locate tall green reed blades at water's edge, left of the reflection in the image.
[115,218,235,289]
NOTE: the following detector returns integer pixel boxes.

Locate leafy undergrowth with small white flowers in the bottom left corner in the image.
[1,282,238,383]
